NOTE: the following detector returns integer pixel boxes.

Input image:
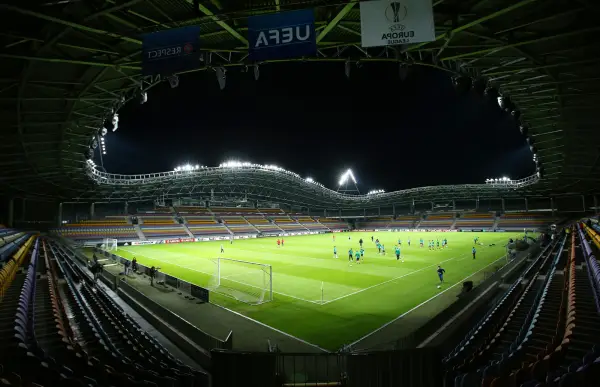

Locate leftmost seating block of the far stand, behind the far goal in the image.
[50,217,138,241]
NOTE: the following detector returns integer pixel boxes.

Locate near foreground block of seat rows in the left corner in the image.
[0,236,208,387]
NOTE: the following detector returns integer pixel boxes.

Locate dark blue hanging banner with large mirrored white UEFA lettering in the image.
[248,9,317,61]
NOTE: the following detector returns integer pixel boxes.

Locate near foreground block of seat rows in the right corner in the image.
[446,229,600,387]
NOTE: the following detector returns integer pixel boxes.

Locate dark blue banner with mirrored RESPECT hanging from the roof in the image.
[142,26,200,75]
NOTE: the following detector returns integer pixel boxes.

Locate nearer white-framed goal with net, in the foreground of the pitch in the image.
[208,258,273,305]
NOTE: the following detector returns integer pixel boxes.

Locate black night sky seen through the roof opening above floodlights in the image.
[104,63,534,192]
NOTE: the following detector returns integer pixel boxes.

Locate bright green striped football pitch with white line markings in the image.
[117,232,519,350]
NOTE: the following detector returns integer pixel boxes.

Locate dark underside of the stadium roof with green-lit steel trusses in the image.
[0,0,600,203]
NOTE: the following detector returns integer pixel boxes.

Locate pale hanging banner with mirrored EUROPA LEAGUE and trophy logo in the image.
[360,0,435,47]
